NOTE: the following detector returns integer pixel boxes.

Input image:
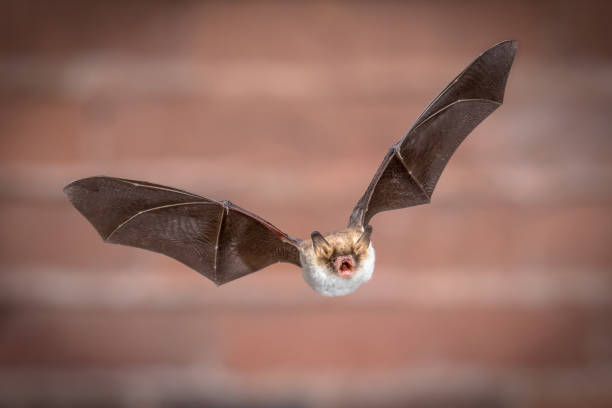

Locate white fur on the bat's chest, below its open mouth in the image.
[300,243,375,296]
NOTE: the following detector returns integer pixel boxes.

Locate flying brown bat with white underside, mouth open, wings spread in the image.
[64,41,516,296]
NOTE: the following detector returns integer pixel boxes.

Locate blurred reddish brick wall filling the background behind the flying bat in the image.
[0,1,612,408]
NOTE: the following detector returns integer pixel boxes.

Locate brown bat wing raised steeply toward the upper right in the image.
[349,41,516,227]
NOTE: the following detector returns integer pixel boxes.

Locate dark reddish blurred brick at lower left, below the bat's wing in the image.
[0,310,218,368]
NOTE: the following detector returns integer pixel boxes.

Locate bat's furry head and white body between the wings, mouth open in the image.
[300,227,374,296]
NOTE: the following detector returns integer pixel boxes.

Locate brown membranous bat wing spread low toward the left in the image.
[64,177,300,285]
